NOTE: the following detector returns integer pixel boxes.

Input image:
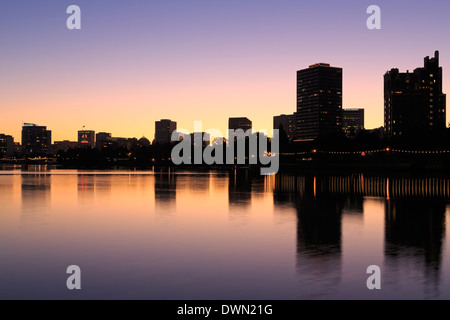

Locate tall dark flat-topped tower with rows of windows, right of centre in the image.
[296,63,342,141]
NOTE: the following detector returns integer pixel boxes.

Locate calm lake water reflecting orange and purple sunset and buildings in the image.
[0,168,450,299]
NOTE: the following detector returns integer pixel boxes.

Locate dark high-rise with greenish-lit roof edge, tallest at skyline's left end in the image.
[22,123,52,156]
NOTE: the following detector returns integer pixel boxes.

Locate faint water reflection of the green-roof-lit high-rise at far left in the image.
[21,171,51,225]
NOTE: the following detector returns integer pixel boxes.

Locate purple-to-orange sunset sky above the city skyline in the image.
[0,0,450,142]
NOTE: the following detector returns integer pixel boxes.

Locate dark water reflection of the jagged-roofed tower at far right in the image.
[385,197,445,298]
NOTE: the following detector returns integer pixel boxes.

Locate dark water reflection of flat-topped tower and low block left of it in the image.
[274,175,345,298]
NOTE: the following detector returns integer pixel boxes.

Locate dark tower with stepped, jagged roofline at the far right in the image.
[384,51,446,138]
